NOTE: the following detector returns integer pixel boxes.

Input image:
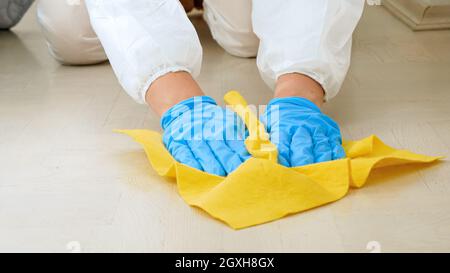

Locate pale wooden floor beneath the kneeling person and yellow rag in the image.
[0,3,450,252]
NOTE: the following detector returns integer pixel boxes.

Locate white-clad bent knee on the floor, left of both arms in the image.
[37,0,107,65]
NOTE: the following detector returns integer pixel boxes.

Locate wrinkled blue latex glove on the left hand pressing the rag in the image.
[161,96,250,176]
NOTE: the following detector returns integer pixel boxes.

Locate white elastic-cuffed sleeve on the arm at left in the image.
[86,0,202,103]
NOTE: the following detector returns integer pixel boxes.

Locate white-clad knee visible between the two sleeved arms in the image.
[203,0,259,57]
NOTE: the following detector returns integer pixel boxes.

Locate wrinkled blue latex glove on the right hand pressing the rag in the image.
[261,97,345,167]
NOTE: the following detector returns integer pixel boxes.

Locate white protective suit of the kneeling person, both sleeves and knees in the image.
[38,0,365,103]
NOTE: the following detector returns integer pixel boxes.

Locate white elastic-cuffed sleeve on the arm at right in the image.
[252,0,364,100]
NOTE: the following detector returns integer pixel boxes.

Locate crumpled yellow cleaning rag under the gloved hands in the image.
[117,91,441,229]
